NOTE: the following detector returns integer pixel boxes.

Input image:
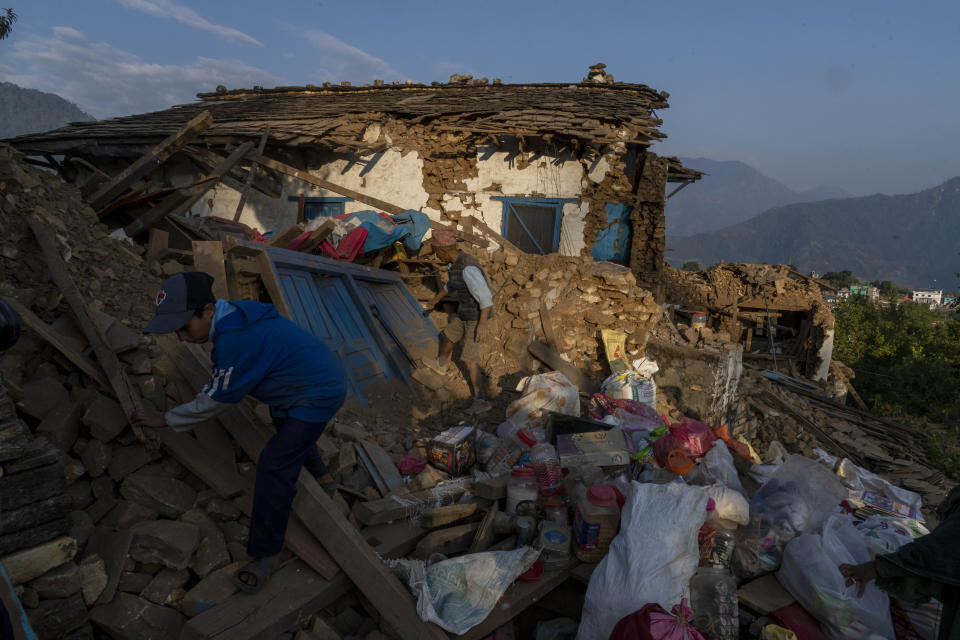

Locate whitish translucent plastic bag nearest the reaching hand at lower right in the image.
[777,516,894,640]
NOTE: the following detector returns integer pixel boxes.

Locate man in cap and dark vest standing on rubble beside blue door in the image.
[423,229,493,414]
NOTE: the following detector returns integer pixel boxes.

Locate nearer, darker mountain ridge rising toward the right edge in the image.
[667,177,960,289]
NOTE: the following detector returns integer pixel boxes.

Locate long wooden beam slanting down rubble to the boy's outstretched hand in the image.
[27,214,144,440]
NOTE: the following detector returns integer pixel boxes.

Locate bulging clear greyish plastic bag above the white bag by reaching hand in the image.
[733,455,847,581]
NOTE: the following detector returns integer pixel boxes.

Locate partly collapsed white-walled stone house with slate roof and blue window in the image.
[5,65,700,293]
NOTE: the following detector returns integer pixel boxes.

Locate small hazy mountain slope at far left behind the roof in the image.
[0,82,93,140]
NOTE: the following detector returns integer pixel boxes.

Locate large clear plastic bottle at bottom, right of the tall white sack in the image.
[690,567,740,640]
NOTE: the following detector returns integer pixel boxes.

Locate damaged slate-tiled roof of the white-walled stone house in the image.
[5,81,669,154]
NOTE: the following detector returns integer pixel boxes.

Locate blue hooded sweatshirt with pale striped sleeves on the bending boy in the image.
[167,300,346,430]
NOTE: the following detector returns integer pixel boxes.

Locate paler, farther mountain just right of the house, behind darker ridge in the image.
[667,158,850,236]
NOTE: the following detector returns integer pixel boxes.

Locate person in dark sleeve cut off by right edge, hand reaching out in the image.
[840,486,960,640]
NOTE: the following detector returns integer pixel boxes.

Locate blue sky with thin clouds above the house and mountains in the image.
[0,0,960,195]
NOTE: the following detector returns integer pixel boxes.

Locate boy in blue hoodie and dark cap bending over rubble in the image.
[131,272,346,592]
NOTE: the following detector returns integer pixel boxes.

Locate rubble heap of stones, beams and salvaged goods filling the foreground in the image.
[0,141,948,640]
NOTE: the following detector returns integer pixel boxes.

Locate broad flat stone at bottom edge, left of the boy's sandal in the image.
[90,593,185,640]
